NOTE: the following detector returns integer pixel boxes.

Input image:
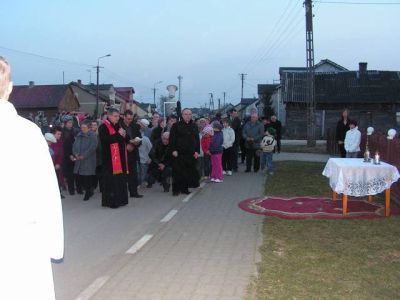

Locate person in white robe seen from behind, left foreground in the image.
[0,57,64,300]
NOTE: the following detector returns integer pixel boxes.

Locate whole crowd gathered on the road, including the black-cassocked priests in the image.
[39,108,281,208]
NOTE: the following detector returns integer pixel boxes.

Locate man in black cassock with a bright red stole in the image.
[99,108,129,208]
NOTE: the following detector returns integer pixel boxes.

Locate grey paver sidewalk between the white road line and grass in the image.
[91,168,264,300]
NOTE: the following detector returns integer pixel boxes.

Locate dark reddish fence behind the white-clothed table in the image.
[326,129,400,203]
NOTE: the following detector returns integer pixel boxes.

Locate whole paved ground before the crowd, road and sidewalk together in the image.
[53,164,264,300]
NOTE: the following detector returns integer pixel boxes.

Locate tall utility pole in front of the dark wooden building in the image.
[304,0,316,147]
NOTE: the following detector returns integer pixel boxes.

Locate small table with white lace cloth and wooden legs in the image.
[322,158,400,216]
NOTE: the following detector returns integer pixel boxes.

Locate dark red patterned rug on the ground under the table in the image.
[239,196,400,219]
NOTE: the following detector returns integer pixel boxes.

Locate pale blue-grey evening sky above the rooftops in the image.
[0,0,400,107]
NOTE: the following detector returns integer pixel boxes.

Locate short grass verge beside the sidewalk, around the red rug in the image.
[248,162,400,299]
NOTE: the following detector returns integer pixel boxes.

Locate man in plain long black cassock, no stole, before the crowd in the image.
[169,109,200,196]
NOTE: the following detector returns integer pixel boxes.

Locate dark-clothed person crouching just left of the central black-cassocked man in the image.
[147,132,172,193]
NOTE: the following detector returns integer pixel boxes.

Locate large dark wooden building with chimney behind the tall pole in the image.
[277,59,400,139]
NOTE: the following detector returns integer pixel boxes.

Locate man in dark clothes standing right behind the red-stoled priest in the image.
[120,110,143,198]
